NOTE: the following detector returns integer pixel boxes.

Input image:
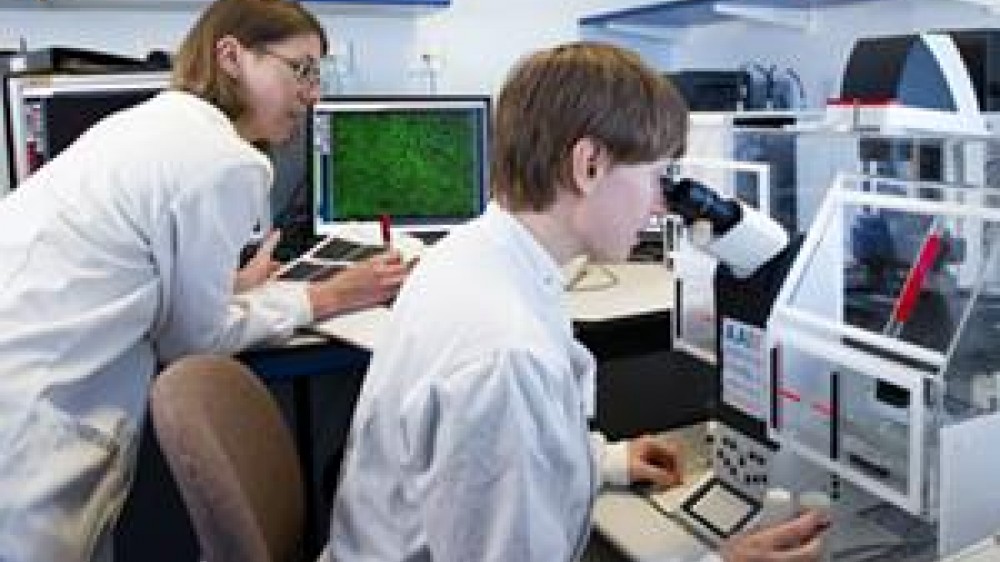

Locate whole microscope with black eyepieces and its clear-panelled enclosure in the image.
[645,175,1000,561]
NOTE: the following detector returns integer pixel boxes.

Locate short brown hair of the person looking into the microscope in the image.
[490,41,688,211]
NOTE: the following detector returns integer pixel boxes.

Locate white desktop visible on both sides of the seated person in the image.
[312,263,674,349]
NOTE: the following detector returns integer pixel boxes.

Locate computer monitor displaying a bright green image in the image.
[308,95,490,234]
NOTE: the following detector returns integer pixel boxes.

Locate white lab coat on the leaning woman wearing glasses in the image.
[0,92,310,562]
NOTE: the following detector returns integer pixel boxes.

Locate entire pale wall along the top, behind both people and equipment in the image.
[9,0,1000,101]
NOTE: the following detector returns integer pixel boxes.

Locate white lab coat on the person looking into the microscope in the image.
[325,204,627,562]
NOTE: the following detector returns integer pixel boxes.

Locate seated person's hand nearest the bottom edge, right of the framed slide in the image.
[721,511,830,562]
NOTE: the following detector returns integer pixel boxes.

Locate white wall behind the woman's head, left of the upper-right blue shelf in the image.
[0,0,632,93]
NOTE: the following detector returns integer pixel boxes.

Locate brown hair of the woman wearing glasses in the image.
[172,0,328,119]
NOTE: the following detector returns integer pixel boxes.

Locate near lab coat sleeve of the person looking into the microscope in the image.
[403,353,592,562]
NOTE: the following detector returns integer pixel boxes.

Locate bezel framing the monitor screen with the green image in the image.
[306,94,492,235]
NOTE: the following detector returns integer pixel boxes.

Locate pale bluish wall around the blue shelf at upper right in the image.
[588,0,1000,107]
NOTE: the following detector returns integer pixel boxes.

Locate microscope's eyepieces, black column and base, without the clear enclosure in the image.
[651,177,812,548]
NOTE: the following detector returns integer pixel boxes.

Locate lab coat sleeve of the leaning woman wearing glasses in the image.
[154,158,311,361]
